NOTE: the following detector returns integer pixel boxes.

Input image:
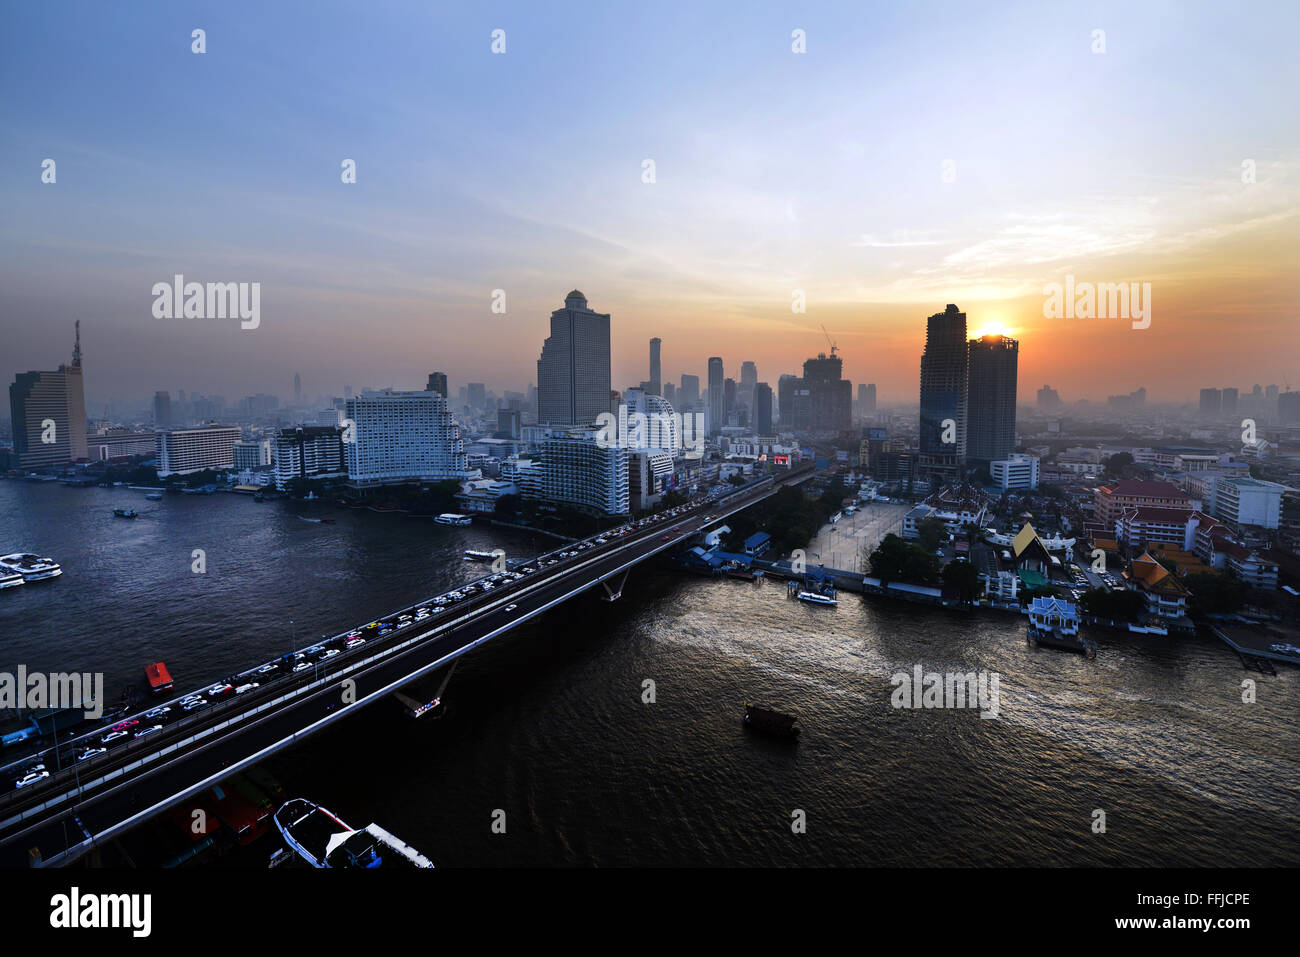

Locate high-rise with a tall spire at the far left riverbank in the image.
[9,321,88,468]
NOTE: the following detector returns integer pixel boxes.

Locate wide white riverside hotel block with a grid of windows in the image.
[343,389,480,488]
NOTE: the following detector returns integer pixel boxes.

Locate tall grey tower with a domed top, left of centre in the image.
[537,289,611,426]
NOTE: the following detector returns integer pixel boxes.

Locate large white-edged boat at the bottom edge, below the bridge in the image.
[276,797,433,870]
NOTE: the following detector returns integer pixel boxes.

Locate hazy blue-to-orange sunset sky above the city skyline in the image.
[0,0,1300,407]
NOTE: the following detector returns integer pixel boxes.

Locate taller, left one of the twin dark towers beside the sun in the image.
[919,303,970,480]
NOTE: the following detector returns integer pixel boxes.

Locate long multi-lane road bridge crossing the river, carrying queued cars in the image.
[0,469,811,867]
